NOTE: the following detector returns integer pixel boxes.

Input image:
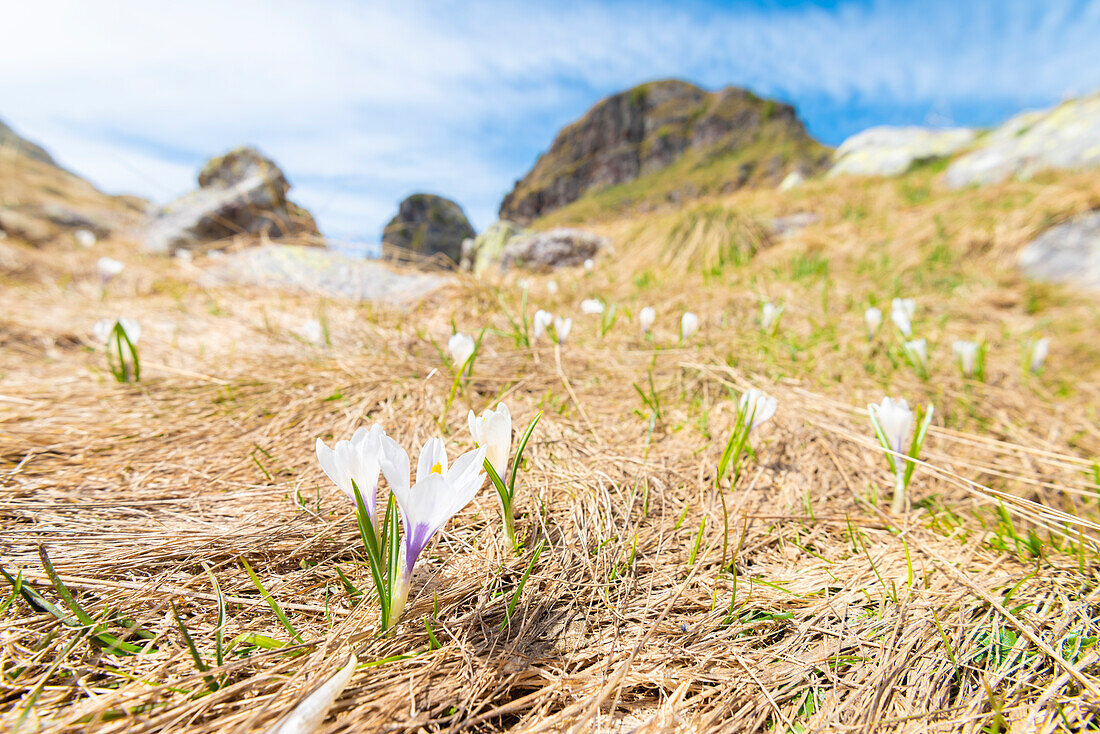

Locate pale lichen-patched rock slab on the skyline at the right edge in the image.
[944,94,1100,187]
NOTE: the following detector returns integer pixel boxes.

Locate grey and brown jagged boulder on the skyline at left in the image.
[143,147,322,254]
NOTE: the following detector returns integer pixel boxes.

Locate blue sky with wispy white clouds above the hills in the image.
[0,0,1100,248]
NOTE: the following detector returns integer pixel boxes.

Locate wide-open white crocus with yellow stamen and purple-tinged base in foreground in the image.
[382,436,486,622]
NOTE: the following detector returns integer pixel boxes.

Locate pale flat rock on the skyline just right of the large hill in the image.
[828,127,975,177]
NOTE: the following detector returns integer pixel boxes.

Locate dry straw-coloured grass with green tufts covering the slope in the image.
[0,161,1100,732]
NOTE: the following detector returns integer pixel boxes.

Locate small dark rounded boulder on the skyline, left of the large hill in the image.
[382,194,476,265]
